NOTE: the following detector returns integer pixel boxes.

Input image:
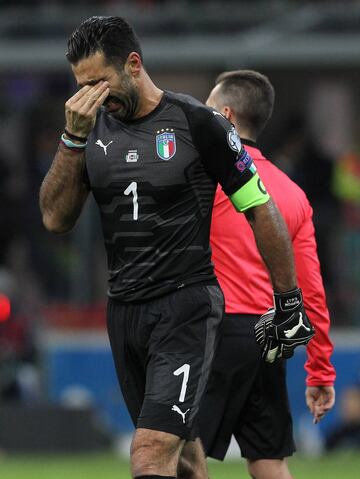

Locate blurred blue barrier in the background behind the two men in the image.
[44,332,360,442]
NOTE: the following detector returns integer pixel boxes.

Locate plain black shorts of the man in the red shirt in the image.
[198,314,295,460]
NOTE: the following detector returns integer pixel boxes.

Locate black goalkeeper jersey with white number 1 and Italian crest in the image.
[86,92,254,302]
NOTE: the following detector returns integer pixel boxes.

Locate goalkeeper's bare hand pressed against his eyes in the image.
[65,81,110,138]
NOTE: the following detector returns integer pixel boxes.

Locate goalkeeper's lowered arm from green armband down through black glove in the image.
[230,183,314,363]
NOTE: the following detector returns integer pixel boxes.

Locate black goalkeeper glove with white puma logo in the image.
[255,289,315,363]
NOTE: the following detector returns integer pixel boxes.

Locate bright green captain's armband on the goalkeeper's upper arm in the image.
[229,173,270,212]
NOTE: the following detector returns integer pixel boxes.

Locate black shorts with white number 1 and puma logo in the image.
[107,285,224,439]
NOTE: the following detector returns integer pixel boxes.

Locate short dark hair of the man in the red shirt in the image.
[216,70,275,137]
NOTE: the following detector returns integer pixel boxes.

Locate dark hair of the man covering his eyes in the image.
[66,17,142,67]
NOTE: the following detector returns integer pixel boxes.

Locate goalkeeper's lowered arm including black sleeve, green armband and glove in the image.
[188,109,314,362]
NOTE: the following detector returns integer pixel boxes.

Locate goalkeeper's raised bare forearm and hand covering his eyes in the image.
[40,82,109,233]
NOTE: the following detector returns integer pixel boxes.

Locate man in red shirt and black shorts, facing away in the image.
[181,70,335,479]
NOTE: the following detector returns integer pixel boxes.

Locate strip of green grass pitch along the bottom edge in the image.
[0,453,360,479]
